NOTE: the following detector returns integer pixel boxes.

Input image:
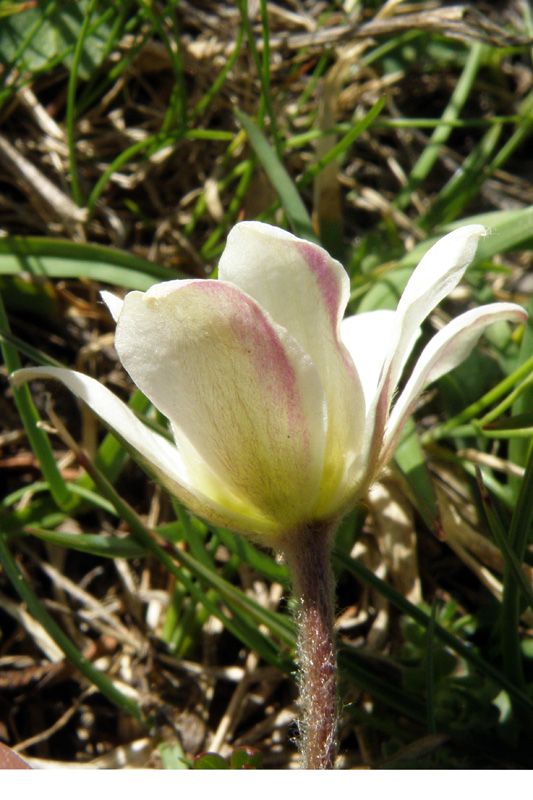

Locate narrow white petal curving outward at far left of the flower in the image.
[11,367,275,534]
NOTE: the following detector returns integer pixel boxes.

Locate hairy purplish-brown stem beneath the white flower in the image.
[282,523,338,769]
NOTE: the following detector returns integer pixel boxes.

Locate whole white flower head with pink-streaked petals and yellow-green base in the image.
[13,222,527,542]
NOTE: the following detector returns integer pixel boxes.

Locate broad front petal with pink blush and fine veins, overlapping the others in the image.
[115,280,327,527]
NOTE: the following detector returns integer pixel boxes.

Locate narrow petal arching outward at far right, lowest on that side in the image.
[382,303,527,461]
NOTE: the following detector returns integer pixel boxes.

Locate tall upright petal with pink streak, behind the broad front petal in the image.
[218,222,365,515]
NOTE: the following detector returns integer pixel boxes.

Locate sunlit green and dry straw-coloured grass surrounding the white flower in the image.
[0,0,533,768]
